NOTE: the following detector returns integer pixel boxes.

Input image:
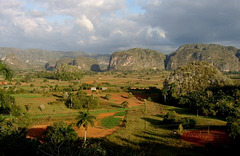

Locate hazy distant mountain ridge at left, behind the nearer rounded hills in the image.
[0,47,110,70]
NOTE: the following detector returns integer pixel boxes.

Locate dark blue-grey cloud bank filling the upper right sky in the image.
[139,0,240,44]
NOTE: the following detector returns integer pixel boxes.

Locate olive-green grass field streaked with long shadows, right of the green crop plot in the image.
[106,102,229,155]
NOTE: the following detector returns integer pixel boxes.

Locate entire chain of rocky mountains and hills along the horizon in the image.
[0,44,240,72]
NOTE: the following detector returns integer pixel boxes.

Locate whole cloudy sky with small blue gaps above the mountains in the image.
[0,0,240,54]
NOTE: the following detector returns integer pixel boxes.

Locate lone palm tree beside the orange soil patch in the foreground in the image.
[76,112,96,142]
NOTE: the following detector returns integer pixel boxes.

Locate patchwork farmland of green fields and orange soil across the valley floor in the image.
[1,71,236,155]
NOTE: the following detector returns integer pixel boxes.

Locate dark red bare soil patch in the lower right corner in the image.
[181,130,230,146]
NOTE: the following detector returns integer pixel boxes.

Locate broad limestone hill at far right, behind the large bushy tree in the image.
[166,44,240,72]
